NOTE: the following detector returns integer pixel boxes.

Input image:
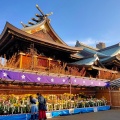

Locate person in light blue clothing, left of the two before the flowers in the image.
[30,95,38,120]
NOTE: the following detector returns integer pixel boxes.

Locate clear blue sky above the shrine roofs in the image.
[0,0,120,47]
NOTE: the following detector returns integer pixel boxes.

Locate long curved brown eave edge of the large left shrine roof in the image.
[0,22,82,53]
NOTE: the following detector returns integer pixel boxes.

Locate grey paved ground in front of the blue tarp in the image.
[48,109,120,120]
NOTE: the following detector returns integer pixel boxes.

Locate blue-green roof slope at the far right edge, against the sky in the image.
[98,43,120,56]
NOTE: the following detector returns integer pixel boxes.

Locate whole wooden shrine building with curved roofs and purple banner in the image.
[0,5,120,105]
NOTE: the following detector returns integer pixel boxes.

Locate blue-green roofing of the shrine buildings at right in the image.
[76,41,120,65]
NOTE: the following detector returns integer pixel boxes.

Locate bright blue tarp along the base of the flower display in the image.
[0,106,110,120]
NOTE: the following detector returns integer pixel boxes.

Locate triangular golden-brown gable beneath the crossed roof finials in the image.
[22,17,67,45]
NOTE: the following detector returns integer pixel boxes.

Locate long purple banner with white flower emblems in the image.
[0,70,107,86]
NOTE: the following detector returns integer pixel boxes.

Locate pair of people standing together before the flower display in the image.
[30,93,47,120]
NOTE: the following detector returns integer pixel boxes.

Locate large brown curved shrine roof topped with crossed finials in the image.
[0,5,82,59]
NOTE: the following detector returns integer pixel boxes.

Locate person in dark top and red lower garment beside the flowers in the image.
[37,93,47,120]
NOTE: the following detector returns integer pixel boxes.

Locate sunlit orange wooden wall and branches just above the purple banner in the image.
[0,53,120,80]
